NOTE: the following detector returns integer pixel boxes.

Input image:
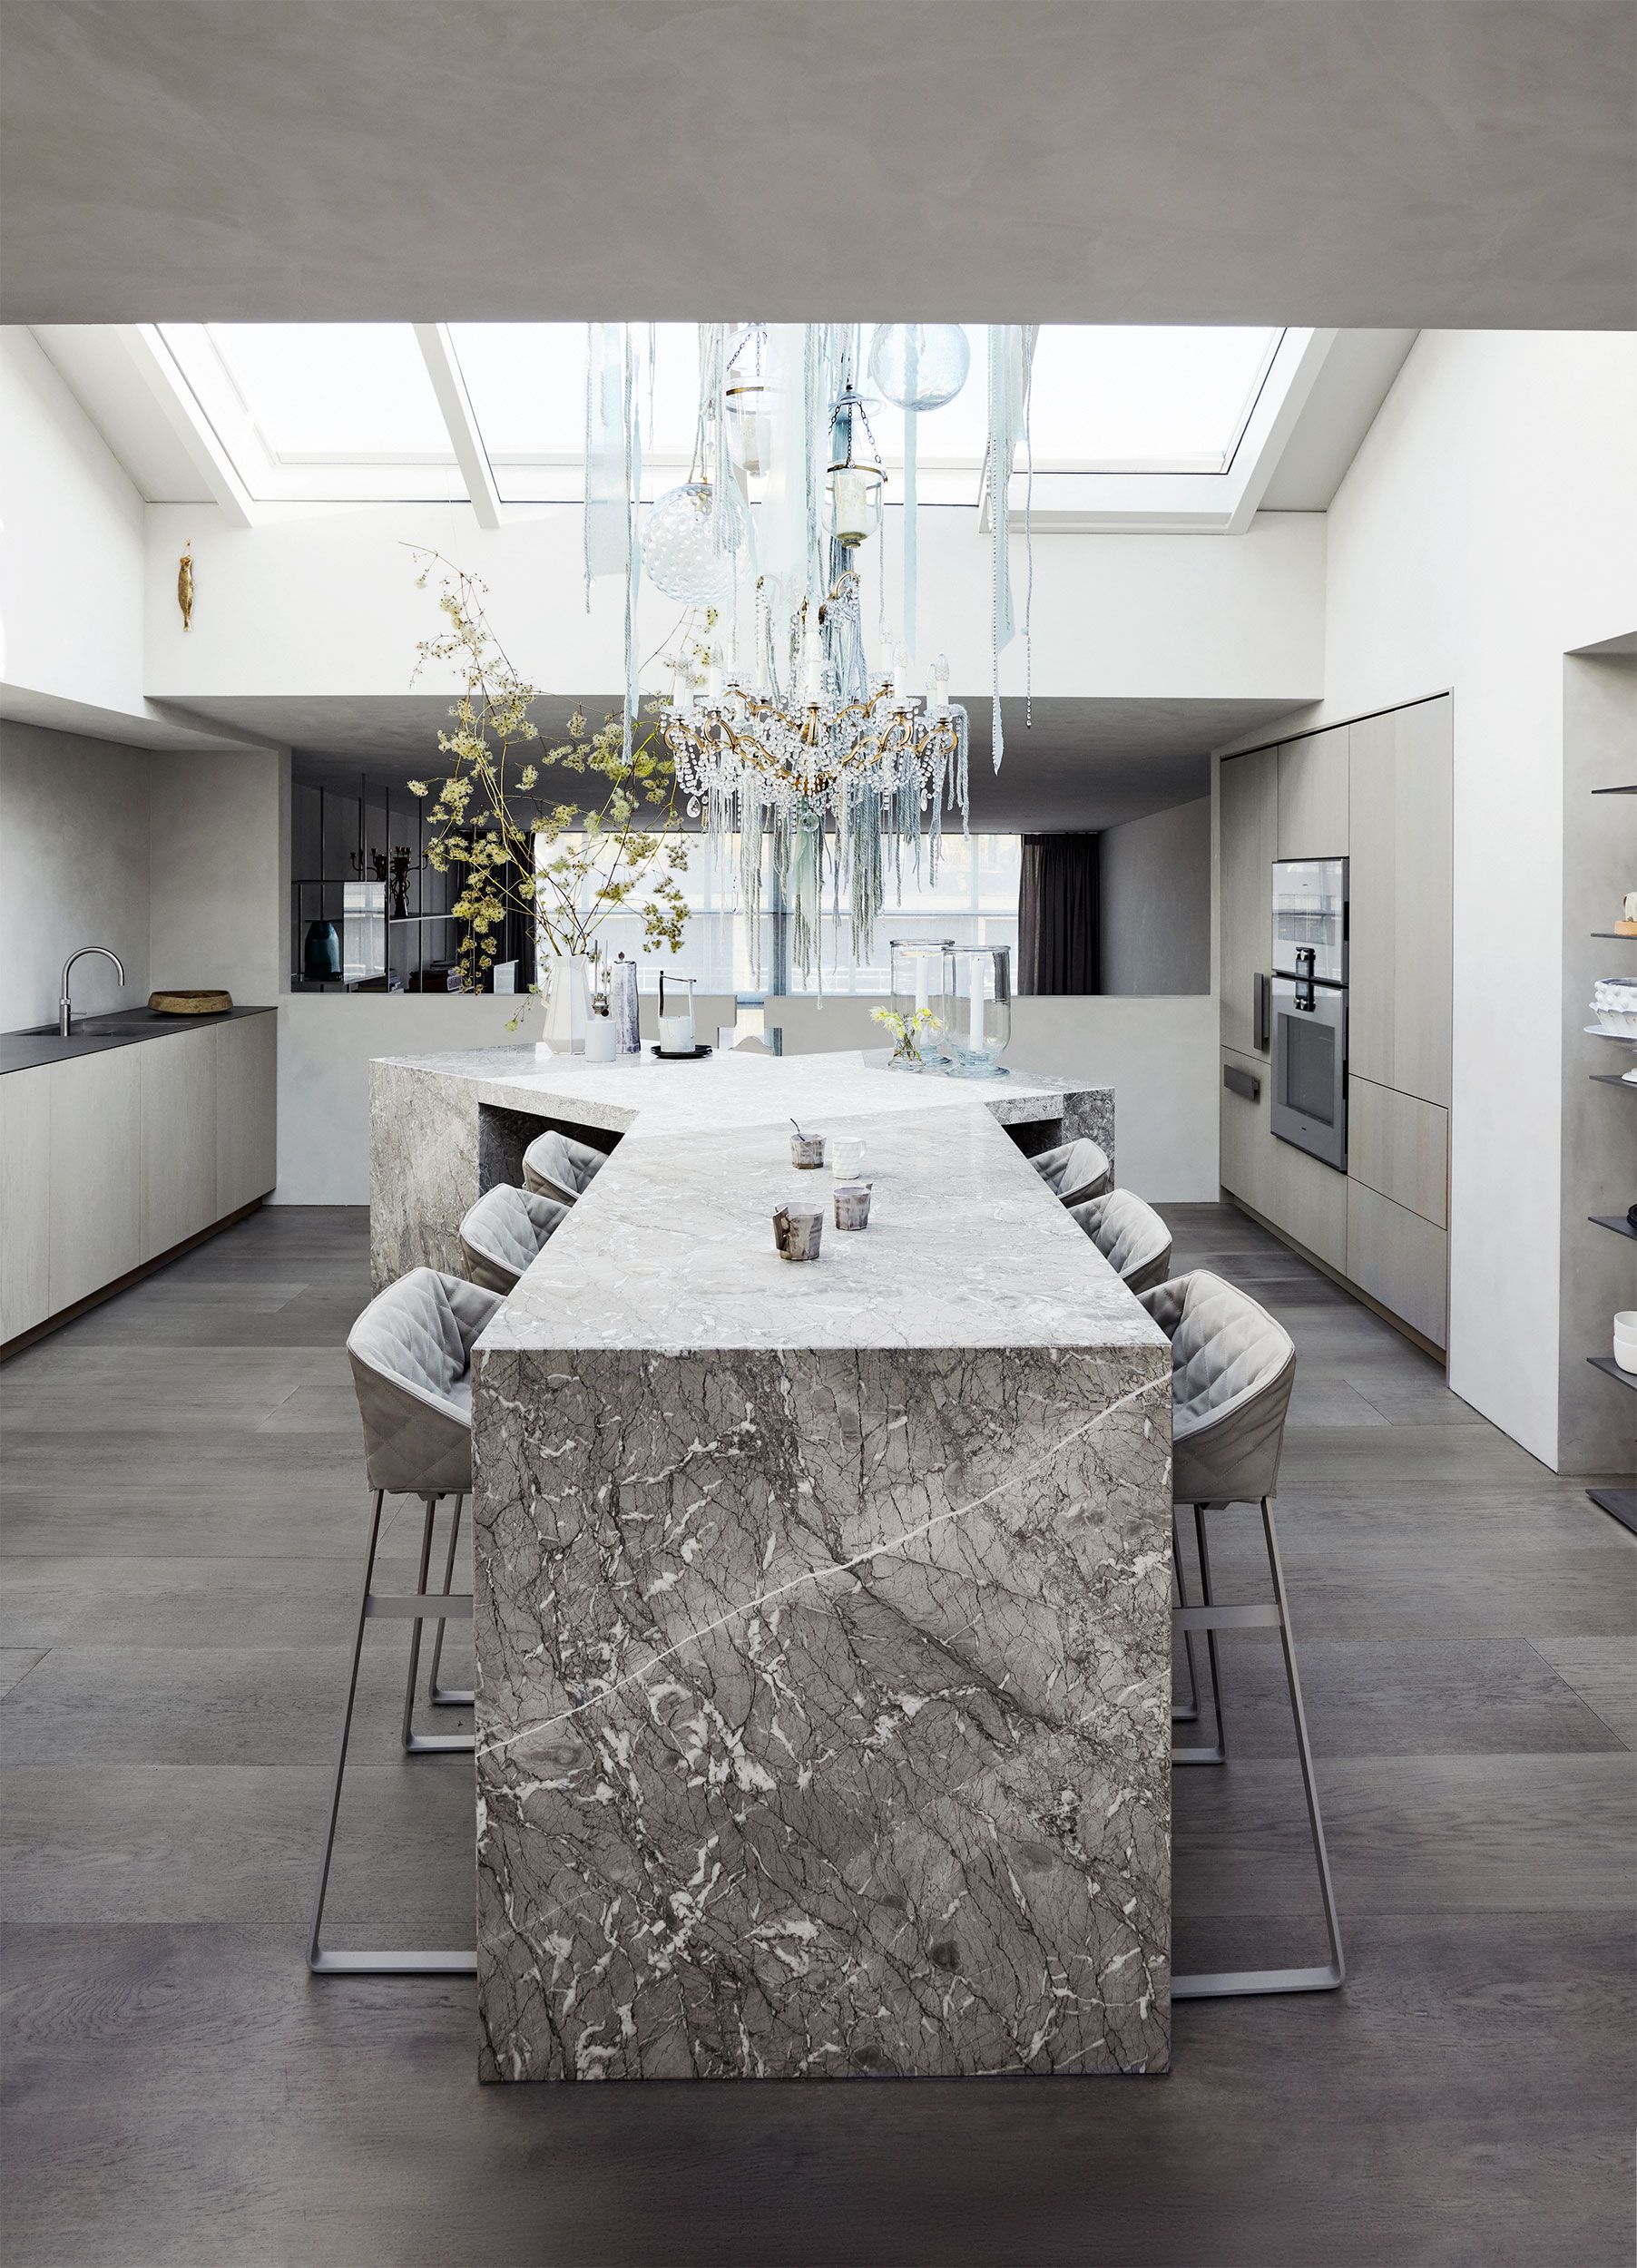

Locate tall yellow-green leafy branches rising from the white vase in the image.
[408,547,687,992]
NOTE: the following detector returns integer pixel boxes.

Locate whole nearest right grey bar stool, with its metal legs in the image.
[1141,1268,1347,2000]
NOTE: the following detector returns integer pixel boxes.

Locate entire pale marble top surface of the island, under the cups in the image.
[383,1048,1161,1354]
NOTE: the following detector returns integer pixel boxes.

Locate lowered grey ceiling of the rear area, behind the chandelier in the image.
[168,694,1290,835]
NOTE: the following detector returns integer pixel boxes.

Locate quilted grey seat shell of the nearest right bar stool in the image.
[1141,1268,1297,1504]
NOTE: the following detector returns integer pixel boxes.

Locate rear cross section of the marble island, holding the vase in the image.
[369,1046,1113,1286]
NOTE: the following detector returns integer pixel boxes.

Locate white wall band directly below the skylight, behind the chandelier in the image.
[147,503,1324,703]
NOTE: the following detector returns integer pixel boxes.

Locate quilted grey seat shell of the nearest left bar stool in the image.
[347,1268,501,1497]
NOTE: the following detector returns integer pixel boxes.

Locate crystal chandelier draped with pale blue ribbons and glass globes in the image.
[587,325,1027,973]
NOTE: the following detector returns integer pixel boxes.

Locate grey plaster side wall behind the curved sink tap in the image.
[0,724,150,1032]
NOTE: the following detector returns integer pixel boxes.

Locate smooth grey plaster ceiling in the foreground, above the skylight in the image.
[0,0,1637,329]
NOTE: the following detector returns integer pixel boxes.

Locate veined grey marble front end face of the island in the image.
[474,1334,1170,2080]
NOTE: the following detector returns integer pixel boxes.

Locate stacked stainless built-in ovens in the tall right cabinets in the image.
[1268,857,1347,1173]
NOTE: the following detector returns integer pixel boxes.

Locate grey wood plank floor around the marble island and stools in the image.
[0,1207,1637,2268]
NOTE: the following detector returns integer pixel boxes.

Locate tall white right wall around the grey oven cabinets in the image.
[1215,331,1637,1465]
